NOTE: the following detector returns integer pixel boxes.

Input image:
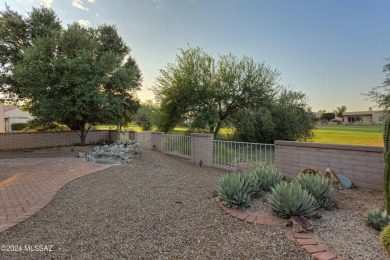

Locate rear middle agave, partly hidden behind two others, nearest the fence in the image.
[251,165,282,191]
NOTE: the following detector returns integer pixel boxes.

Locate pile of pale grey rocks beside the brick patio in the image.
[79,140,142,164]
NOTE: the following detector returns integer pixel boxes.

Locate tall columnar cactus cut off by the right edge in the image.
[383,115,390,212]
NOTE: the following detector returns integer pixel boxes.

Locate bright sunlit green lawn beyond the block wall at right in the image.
[313,125,383,146]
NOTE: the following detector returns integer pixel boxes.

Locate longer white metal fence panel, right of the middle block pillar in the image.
[213,140,275,167]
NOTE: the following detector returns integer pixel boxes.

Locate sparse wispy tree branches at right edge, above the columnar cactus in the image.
[363,59,390,110]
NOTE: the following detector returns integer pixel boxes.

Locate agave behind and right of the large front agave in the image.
[297,174,336,209]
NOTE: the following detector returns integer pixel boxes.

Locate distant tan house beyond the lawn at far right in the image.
[343,107,384,125]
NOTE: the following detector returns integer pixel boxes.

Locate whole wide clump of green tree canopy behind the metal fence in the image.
[154,47,313,142]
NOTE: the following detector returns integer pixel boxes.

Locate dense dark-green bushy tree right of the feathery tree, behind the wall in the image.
[234,88,314,143]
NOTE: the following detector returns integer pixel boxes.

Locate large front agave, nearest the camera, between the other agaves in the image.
[269,182,319,218]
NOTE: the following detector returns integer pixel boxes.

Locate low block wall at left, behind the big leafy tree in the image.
[0,130,117,150]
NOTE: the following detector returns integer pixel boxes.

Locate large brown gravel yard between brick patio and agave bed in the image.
[0,148,312,260]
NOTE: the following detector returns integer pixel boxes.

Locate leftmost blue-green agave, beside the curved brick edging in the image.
[217,173,253,208]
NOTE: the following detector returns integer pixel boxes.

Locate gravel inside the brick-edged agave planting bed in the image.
[247,184,389,260]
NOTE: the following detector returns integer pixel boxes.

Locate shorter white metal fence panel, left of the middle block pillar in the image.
[163,135,191,157]
